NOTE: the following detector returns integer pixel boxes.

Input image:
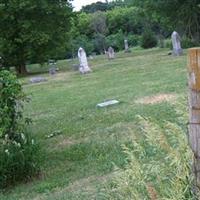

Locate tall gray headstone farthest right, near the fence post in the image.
[171,31,183,56]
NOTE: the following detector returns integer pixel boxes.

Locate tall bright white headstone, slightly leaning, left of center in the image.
[78,47,91,74]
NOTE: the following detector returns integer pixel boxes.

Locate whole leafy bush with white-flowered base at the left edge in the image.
[0,70,39,188]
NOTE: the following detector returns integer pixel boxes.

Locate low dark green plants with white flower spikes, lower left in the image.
[0,133,41,189]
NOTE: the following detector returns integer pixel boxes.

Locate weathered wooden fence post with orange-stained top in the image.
[188,48,200,188]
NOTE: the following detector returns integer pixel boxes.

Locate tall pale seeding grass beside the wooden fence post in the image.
[104,97,199,200]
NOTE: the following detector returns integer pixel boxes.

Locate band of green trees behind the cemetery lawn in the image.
[0,0,200,74]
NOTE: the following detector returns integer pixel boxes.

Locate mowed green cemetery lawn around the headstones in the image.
[0,48,187,200]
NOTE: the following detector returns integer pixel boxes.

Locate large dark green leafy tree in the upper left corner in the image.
[0,0,72,74]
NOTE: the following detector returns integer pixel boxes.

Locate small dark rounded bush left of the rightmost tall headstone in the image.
[141,31,157,49]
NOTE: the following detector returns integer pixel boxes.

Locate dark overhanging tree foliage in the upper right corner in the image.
[125,0,200,44]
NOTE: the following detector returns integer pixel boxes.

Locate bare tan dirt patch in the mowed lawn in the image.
[135,94,176,104]
